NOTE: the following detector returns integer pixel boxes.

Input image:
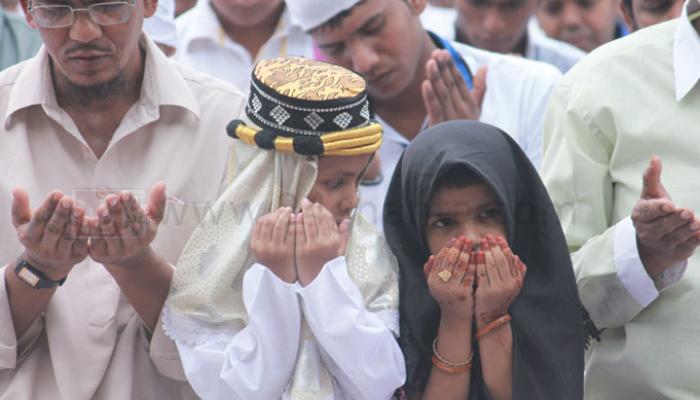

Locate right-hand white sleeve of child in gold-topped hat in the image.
[299,257,406,399]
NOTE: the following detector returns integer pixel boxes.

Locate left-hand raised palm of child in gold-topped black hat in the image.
[250,207,297,283]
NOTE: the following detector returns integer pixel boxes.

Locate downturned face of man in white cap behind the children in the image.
[311,0,426,99]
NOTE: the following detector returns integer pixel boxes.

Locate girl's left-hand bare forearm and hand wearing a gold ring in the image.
[423,239,476,400]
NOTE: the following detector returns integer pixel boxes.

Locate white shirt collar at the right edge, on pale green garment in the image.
[673,0,700,102]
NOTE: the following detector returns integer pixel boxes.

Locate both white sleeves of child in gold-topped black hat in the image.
[172,257,406,400]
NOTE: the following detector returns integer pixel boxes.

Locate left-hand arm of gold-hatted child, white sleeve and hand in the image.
[170,209,301,400]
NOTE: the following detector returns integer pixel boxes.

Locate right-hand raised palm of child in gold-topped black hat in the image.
[295,199,349,286]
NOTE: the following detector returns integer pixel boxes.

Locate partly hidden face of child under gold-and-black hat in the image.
[309,155,370,223]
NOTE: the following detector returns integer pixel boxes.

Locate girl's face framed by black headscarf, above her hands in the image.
[425,183,508,254]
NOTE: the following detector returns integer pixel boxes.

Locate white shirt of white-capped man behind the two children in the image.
[359,42,561,230]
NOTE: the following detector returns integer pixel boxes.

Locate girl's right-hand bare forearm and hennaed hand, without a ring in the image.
[475,237,525,400]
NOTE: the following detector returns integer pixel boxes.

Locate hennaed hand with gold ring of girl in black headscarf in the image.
[424,238,476,325]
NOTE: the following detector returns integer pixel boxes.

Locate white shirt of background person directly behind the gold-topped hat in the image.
[174,0,313,92]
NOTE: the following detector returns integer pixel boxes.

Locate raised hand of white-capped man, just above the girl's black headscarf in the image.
[421,50,487,126]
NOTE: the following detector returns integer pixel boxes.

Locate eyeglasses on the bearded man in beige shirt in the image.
[28,0,136,28]
